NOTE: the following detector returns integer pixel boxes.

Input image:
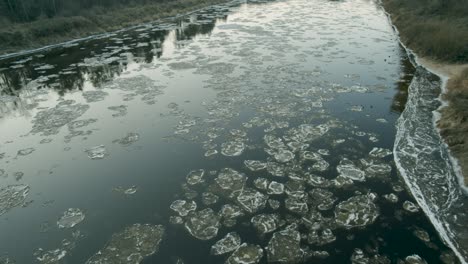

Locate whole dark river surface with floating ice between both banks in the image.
[0,0,457,263]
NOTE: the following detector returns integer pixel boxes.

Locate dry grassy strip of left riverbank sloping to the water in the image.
[0,0,226,54]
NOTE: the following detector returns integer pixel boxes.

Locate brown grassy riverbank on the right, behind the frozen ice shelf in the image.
[382,0,468,186]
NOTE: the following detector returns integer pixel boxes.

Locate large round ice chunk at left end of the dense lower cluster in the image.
[185,208,220,240]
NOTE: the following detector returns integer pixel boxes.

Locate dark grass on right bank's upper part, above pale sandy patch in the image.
[382,0,468,62]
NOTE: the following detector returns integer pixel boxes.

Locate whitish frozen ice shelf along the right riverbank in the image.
[382,4,468,264]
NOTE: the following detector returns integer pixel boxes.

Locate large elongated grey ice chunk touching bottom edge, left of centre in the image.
[86,224,165,264]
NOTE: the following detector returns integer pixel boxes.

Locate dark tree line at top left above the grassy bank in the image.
[0,0,171,23]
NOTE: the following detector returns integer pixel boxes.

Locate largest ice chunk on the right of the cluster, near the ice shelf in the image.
[335,194,379,229]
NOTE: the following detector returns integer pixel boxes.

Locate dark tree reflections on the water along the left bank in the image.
[0,13,219,112]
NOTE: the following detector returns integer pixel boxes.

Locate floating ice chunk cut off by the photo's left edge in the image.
[0,184,29,216]
